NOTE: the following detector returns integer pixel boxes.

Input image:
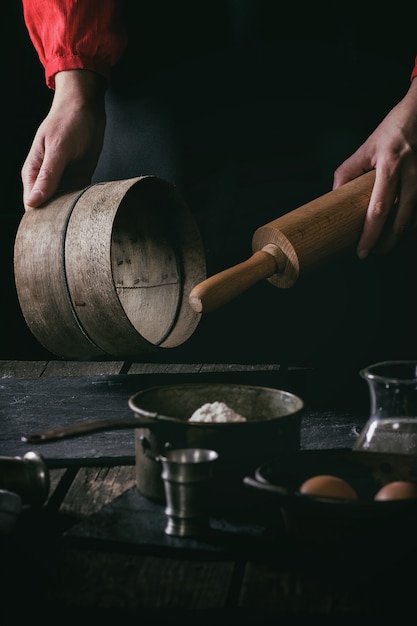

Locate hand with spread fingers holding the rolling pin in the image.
[333,79,417,259]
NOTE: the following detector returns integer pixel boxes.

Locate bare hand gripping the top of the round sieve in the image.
[21,70,107,211]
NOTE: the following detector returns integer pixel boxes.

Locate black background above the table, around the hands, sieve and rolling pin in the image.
[0,0,417,390]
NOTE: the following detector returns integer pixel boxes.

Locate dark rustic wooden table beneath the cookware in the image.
[0,360,417,624]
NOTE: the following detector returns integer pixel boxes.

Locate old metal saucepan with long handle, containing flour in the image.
[24,383,304,501]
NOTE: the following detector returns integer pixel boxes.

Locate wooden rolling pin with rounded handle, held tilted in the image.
[189,170,375,313]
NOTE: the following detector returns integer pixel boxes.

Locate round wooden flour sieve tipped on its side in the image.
[14,176,206,359]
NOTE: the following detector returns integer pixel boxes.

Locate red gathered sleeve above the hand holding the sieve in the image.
[22,0,127,89]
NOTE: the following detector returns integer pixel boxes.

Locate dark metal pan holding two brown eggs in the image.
[244,448,417,542]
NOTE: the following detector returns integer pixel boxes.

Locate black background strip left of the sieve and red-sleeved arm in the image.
[0,2,51,359]
